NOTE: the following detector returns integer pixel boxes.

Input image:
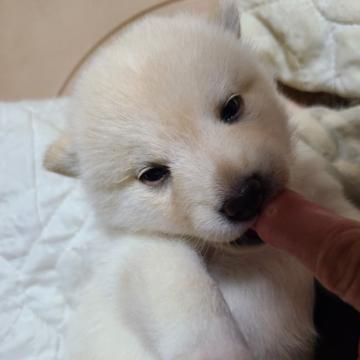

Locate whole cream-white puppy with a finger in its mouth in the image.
[45,4,356,360]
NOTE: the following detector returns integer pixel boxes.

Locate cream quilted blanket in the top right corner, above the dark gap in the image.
[238,0,360,98]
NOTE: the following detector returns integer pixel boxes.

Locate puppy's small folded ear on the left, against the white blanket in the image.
[44,135,79,177]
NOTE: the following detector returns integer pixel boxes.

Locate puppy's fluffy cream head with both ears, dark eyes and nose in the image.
[46,1,290,242]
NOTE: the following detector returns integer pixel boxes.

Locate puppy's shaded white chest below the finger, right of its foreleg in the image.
[210,250,315,360]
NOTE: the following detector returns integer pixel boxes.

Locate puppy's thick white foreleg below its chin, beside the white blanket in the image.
[67,238,250,360]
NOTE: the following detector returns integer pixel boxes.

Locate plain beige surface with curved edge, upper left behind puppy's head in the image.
[0,0,216,100]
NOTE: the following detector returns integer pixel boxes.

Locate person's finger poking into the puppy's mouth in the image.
[255,190,360,311]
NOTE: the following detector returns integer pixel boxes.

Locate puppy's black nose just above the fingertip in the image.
[220,176,266,222]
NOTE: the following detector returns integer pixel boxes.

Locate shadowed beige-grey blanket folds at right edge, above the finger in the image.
[290,102,360,207]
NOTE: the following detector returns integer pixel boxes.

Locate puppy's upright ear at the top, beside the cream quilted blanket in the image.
[214,0,241,38]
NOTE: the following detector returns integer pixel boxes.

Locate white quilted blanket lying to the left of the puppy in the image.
[0,99,97,360]
